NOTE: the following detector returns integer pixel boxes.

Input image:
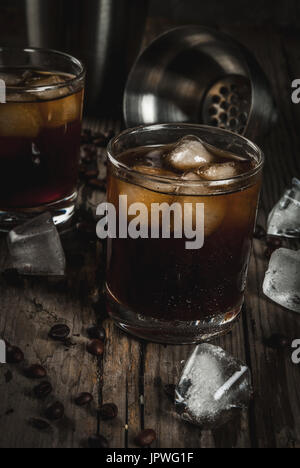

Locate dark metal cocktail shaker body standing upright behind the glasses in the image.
[25,0,148,116]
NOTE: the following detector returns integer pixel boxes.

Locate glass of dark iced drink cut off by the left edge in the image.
[0,50,84,229]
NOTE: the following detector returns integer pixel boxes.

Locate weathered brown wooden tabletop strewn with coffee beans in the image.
[0,22,300,448]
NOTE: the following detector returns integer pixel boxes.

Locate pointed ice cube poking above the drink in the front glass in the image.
[166,136,215,171]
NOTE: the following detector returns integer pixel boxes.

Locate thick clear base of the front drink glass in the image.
[106,287,242,345]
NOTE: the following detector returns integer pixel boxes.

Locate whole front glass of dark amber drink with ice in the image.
[107,125,262,343]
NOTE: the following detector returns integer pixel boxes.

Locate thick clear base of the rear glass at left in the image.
[0,192,77,232]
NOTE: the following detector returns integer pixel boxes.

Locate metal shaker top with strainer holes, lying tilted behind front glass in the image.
[124,26,275,139]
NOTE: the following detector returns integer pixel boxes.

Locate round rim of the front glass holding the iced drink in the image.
[107,123,265,188]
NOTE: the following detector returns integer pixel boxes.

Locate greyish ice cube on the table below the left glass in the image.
[7,213,66,276]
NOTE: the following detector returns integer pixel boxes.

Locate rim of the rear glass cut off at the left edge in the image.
[0,46,86,93]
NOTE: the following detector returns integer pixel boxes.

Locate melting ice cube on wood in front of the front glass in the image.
[176,344,252,429]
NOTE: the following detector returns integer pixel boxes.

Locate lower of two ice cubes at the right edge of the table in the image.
[263,249,300,313]
